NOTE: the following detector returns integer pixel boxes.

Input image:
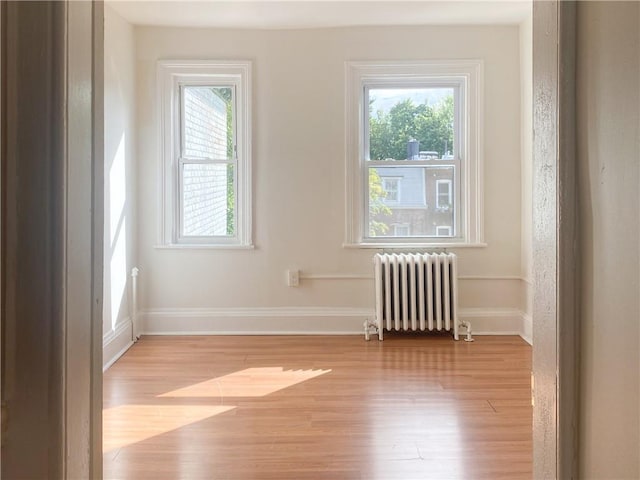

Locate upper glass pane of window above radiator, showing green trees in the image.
[369,88,454,160]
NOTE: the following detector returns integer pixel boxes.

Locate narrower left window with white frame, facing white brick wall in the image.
[158,61,251,247]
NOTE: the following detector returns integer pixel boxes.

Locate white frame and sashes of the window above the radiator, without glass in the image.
[344,60,486,248]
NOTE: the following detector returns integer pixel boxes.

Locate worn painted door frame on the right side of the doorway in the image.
[532,0,579,479]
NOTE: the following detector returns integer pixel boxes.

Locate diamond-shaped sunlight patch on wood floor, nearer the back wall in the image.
[158,367,331,398]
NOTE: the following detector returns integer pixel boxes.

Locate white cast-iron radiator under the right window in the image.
[365,253,472,341]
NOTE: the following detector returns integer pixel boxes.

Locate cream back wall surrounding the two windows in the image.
[136,26,524,331]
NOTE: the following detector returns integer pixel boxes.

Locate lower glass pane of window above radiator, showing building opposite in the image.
[368,164,455,237]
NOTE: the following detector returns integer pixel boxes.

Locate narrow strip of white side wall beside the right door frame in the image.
[520,15,533,341]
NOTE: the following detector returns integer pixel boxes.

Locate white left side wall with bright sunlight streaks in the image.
[103,6,137,365]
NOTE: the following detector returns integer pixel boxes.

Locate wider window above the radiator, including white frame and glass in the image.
[346,61,482,247]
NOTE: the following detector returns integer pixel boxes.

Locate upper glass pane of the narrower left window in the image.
[183,86,233,159]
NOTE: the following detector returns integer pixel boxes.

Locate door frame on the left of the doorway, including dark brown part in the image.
[0,1,104,479]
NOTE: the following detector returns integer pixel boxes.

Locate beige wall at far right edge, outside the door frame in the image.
[577,2,640,479]
